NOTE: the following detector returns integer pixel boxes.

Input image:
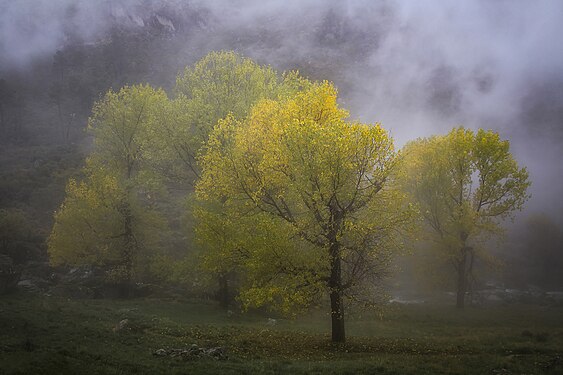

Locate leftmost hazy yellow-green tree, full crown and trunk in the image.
[48,85,167,294]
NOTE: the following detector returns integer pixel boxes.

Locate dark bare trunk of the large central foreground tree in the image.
[329,242,346,342]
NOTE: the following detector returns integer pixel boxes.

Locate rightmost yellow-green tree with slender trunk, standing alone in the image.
[403,128,530,308]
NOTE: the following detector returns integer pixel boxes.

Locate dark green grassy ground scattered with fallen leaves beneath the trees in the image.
[0,294,563,374]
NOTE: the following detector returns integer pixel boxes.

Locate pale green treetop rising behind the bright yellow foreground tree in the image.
[155,51,279,183]
